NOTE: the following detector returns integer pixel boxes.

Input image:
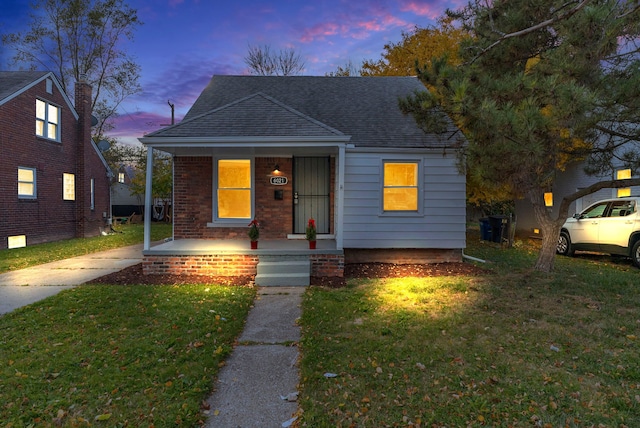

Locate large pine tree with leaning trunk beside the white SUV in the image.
[401,0,640,271]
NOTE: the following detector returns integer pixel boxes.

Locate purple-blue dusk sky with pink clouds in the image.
[0,0,465,143]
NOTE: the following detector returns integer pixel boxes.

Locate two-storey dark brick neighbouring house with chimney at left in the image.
[0,71,110,250]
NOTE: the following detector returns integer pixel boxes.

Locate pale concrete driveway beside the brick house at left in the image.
[0,244,142,314]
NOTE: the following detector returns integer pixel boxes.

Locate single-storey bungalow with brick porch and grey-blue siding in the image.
[140,76,466,285]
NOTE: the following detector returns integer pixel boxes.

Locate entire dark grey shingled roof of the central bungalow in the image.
[146,76,454,147]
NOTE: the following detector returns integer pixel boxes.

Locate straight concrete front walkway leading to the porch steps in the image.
[206,287,305,428]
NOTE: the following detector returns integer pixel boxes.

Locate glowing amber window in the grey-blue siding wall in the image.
[382,162,418,211]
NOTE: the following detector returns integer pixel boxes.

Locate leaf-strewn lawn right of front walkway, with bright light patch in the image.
[299,237,640,427]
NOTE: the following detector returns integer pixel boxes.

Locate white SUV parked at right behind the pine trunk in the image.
[556,197,640,267]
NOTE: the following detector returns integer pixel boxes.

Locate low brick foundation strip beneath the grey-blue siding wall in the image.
[344,248,462,265]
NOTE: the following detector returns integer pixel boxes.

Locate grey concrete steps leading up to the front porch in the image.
[255,257,311,287]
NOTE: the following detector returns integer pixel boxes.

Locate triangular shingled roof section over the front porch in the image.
[147,93,344,138]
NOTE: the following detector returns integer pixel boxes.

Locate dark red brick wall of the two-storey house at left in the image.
[0,75,109,249]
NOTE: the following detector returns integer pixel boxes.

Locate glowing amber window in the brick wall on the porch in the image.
[217,159,252,219]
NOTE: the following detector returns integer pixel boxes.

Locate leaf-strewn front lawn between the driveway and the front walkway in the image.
[0,285,255,428]
